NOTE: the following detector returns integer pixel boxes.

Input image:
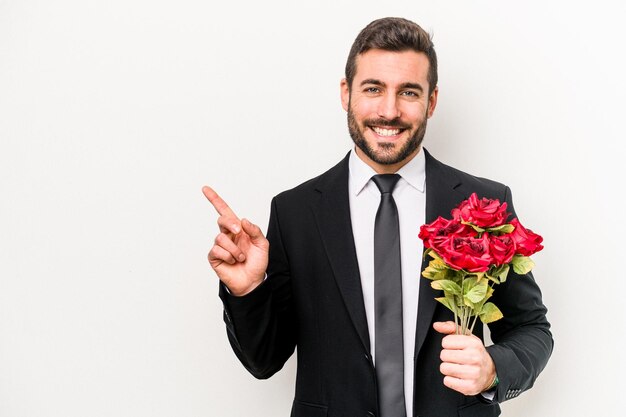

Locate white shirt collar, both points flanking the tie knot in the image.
[349,148,426,195]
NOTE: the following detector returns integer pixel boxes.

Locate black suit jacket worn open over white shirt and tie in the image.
[220,150,553,417]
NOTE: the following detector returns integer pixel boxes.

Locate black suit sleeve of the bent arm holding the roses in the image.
[487,187,554,402]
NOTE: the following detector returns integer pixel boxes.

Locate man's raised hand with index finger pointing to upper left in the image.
[202,186,270,296]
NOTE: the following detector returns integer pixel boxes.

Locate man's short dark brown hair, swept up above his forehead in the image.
[346,17,437,94]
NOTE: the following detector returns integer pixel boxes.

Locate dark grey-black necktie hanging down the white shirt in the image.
[372,174,406,417]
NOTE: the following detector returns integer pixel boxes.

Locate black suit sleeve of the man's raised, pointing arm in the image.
[219,199,297,379]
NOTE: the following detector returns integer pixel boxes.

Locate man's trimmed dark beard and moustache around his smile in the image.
[348,103,428,165]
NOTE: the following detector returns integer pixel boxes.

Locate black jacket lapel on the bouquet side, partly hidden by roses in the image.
[415,149,465,358]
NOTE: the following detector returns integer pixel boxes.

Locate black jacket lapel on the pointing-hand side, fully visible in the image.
[314,154,370,352]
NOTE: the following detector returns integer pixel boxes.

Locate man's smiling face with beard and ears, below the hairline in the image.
[341,49,437,173]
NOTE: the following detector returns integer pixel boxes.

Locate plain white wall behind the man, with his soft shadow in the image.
[0,0,626,417]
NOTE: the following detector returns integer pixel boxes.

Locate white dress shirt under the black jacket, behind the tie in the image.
[349,149,426,416]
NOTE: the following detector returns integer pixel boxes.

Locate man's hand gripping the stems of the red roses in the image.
[433,321,496,395]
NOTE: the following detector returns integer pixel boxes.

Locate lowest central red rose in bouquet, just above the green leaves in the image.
[433,234,493,272]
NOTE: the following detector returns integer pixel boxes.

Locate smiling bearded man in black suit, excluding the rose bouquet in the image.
[203,18,553,417]
